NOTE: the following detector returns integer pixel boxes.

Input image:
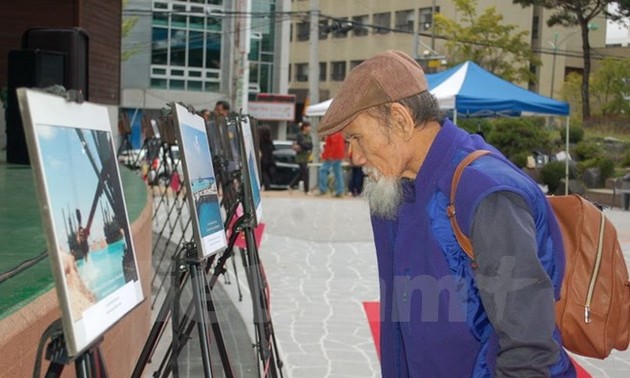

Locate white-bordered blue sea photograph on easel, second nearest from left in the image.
[173,104,227,259]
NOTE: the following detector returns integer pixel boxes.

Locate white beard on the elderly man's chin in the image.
[362,168,402,219]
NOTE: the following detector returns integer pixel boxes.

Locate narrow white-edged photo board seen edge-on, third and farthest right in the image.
[236,116,262,225]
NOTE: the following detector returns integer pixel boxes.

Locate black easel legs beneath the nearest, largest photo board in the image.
[33,319,108,378]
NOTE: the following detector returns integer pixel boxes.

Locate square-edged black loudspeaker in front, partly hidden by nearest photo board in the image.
[5,50,65,164]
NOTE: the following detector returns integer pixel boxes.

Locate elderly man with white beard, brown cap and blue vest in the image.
[318,51,575,377]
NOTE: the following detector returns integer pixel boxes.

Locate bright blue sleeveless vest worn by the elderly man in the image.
[372,120,575,377]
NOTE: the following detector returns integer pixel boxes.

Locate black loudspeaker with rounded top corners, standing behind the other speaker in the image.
[22,28,89,100]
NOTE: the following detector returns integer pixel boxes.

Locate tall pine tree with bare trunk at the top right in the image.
[512,0,630,120]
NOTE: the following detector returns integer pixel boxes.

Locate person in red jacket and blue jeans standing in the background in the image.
[319,133,346,197]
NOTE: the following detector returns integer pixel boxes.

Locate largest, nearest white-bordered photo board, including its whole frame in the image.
[17,88,143,356]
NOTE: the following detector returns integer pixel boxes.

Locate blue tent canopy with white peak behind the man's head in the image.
[426,61,569,119]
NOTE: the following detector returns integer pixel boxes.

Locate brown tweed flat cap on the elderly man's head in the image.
[317,50,427,136]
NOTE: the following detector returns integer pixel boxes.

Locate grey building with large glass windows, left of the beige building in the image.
[121,0,289,144]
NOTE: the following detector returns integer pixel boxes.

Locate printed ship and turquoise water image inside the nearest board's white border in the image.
[37,125,138,321]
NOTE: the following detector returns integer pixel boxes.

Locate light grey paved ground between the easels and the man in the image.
[152,191,630,378]
